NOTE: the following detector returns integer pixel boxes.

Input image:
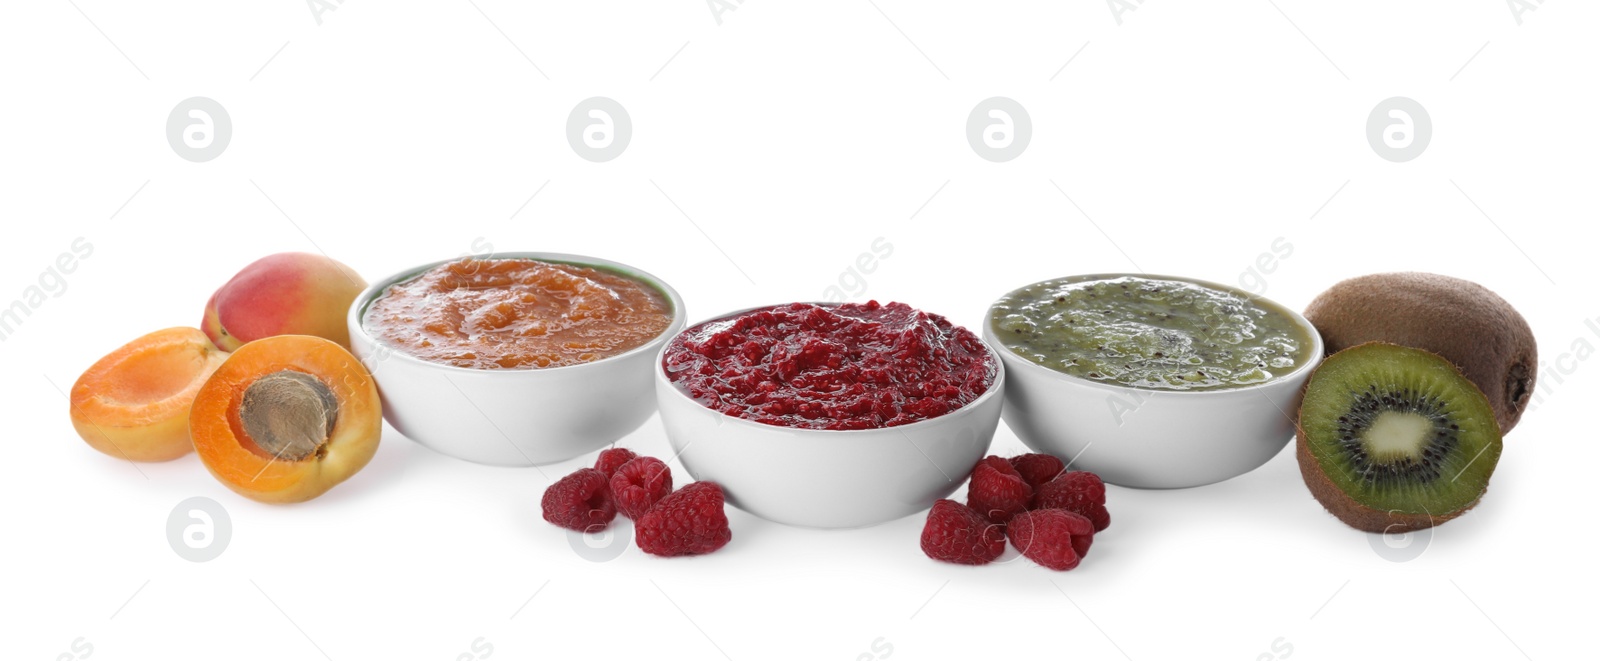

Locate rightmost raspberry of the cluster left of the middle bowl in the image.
[634,482,733,555]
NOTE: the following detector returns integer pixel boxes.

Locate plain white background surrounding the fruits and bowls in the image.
[0,0,1600,661]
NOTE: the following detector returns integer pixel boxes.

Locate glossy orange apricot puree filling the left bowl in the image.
[362,258,674,370]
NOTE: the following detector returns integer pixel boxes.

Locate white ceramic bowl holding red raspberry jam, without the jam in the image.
[654,306,1005,528]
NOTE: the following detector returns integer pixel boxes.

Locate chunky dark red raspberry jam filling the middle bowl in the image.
[662,301,998,429]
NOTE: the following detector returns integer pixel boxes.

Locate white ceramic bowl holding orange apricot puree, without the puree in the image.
[347,253,686,466]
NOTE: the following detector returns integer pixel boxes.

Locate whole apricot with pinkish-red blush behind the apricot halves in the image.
[200,253,366,352]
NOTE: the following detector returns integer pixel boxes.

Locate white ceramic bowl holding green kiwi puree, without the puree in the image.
[982,274,1323,488]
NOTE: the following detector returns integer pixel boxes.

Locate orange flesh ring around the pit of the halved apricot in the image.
[189,335,382,504]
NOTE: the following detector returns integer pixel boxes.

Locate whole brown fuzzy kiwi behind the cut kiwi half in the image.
[1306,272,1539,435]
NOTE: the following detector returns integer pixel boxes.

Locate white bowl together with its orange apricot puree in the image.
[349,253,686,466]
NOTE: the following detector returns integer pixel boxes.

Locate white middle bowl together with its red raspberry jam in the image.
[656,301,1005,528]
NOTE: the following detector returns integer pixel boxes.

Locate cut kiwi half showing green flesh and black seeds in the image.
[1294,343,1501,533]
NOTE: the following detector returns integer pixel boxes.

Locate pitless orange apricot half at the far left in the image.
[69,328,227,461]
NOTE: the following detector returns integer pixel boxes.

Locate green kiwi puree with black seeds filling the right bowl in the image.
[989,275,1315,391]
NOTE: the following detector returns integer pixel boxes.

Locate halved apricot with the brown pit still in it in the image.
[189,335,382,503]
